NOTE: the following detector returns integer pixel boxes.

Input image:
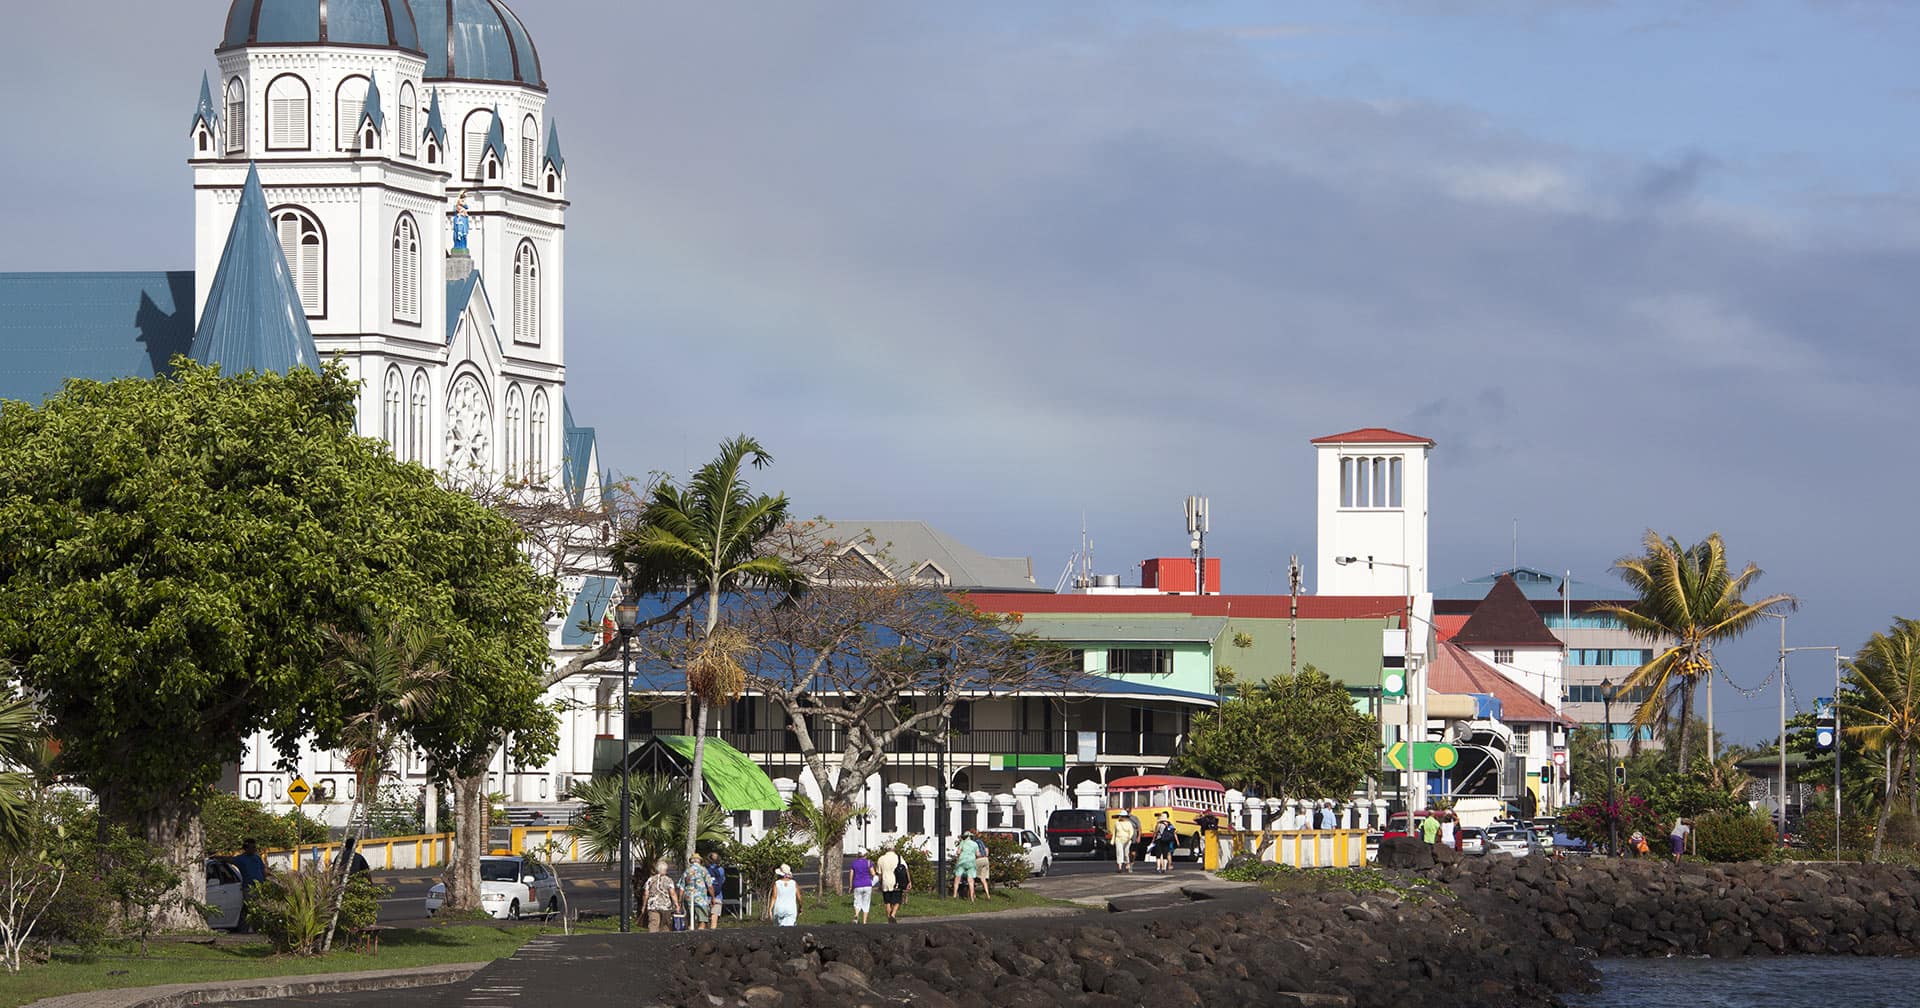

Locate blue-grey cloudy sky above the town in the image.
[0,0,1920,741]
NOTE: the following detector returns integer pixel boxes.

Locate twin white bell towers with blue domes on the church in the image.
[190,0,566,488]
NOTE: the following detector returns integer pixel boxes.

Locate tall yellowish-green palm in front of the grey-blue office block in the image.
[1596,528,1797,774]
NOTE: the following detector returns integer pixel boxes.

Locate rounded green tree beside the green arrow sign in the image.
[1173,664,1380,799]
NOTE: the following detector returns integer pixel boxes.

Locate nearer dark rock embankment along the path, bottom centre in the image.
[641,874,1592,1008]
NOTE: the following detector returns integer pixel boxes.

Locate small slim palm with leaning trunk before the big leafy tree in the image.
[321,612,449,954]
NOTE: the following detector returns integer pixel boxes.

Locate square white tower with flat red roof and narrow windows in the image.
[1313,426,1434,595]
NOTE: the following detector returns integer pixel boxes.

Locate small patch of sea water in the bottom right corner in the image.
[1567,956,1920,1008]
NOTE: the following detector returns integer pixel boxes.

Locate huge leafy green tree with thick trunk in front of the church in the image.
[0,359,553,927]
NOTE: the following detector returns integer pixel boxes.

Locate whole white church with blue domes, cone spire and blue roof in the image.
[0,0,618,820]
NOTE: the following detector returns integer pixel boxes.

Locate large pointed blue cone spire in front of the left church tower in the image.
[190,165,321,374]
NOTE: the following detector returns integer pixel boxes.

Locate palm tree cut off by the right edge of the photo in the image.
[1836,618,1920,860]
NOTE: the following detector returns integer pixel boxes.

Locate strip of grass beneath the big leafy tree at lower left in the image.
[0,922,612,1008]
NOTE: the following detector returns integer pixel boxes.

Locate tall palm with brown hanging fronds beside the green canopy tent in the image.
[614,434,801,858]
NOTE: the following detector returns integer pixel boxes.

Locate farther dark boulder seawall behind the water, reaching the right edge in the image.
[1419,840,1920,958]
